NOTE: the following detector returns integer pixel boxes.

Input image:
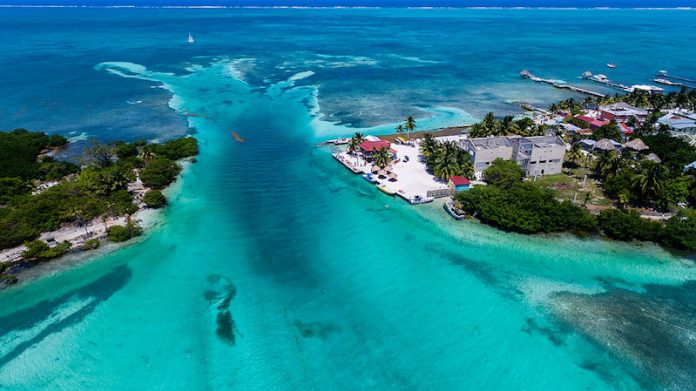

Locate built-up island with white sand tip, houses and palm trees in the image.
[333,88,696,253]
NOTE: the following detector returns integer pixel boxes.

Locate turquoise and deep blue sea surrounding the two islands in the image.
[0,10,696,390]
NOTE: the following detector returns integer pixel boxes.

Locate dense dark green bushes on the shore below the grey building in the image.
[456,159,595,234]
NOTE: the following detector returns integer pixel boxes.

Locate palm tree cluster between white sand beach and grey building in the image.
[420,133,474,180]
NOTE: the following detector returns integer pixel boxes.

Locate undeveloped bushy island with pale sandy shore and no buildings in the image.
[0,129,198,286]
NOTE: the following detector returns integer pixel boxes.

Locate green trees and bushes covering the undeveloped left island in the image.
[0,129,198,253]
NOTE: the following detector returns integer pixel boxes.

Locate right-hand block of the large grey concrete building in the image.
[511,135,566,176]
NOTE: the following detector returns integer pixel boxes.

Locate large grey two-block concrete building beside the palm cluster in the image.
[459,136,566,178]
